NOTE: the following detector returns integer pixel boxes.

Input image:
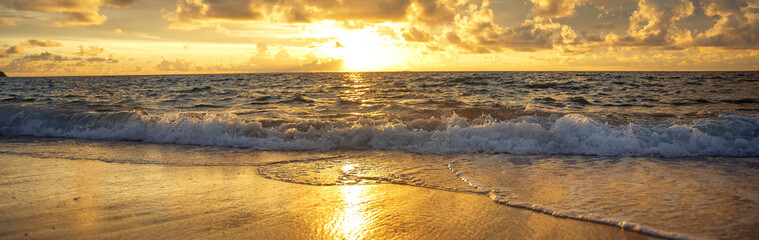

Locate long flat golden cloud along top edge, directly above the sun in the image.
[164,0,466,29]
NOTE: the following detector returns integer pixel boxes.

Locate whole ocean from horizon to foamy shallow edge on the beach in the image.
[0,72,759,239]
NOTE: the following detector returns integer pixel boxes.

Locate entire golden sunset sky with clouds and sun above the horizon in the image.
[0,0,759,76]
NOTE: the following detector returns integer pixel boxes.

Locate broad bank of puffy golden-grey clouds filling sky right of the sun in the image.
[458,0,759,53]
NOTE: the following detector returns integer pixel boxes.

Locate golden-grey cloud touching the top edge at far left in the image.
[4,0,137,26]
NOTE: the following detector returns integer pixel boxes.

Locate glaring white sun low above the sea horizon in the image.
[308,22,406,72]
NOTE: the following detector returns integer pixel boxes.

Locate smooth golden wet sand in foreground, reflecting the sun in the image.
[0,154,649,239]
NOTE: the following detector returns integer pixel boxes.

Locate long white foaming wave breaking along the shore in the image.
[0,105,759,157]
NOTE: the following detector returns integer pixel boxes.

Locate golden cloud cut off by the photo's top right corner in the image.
[696,0,759,49]
